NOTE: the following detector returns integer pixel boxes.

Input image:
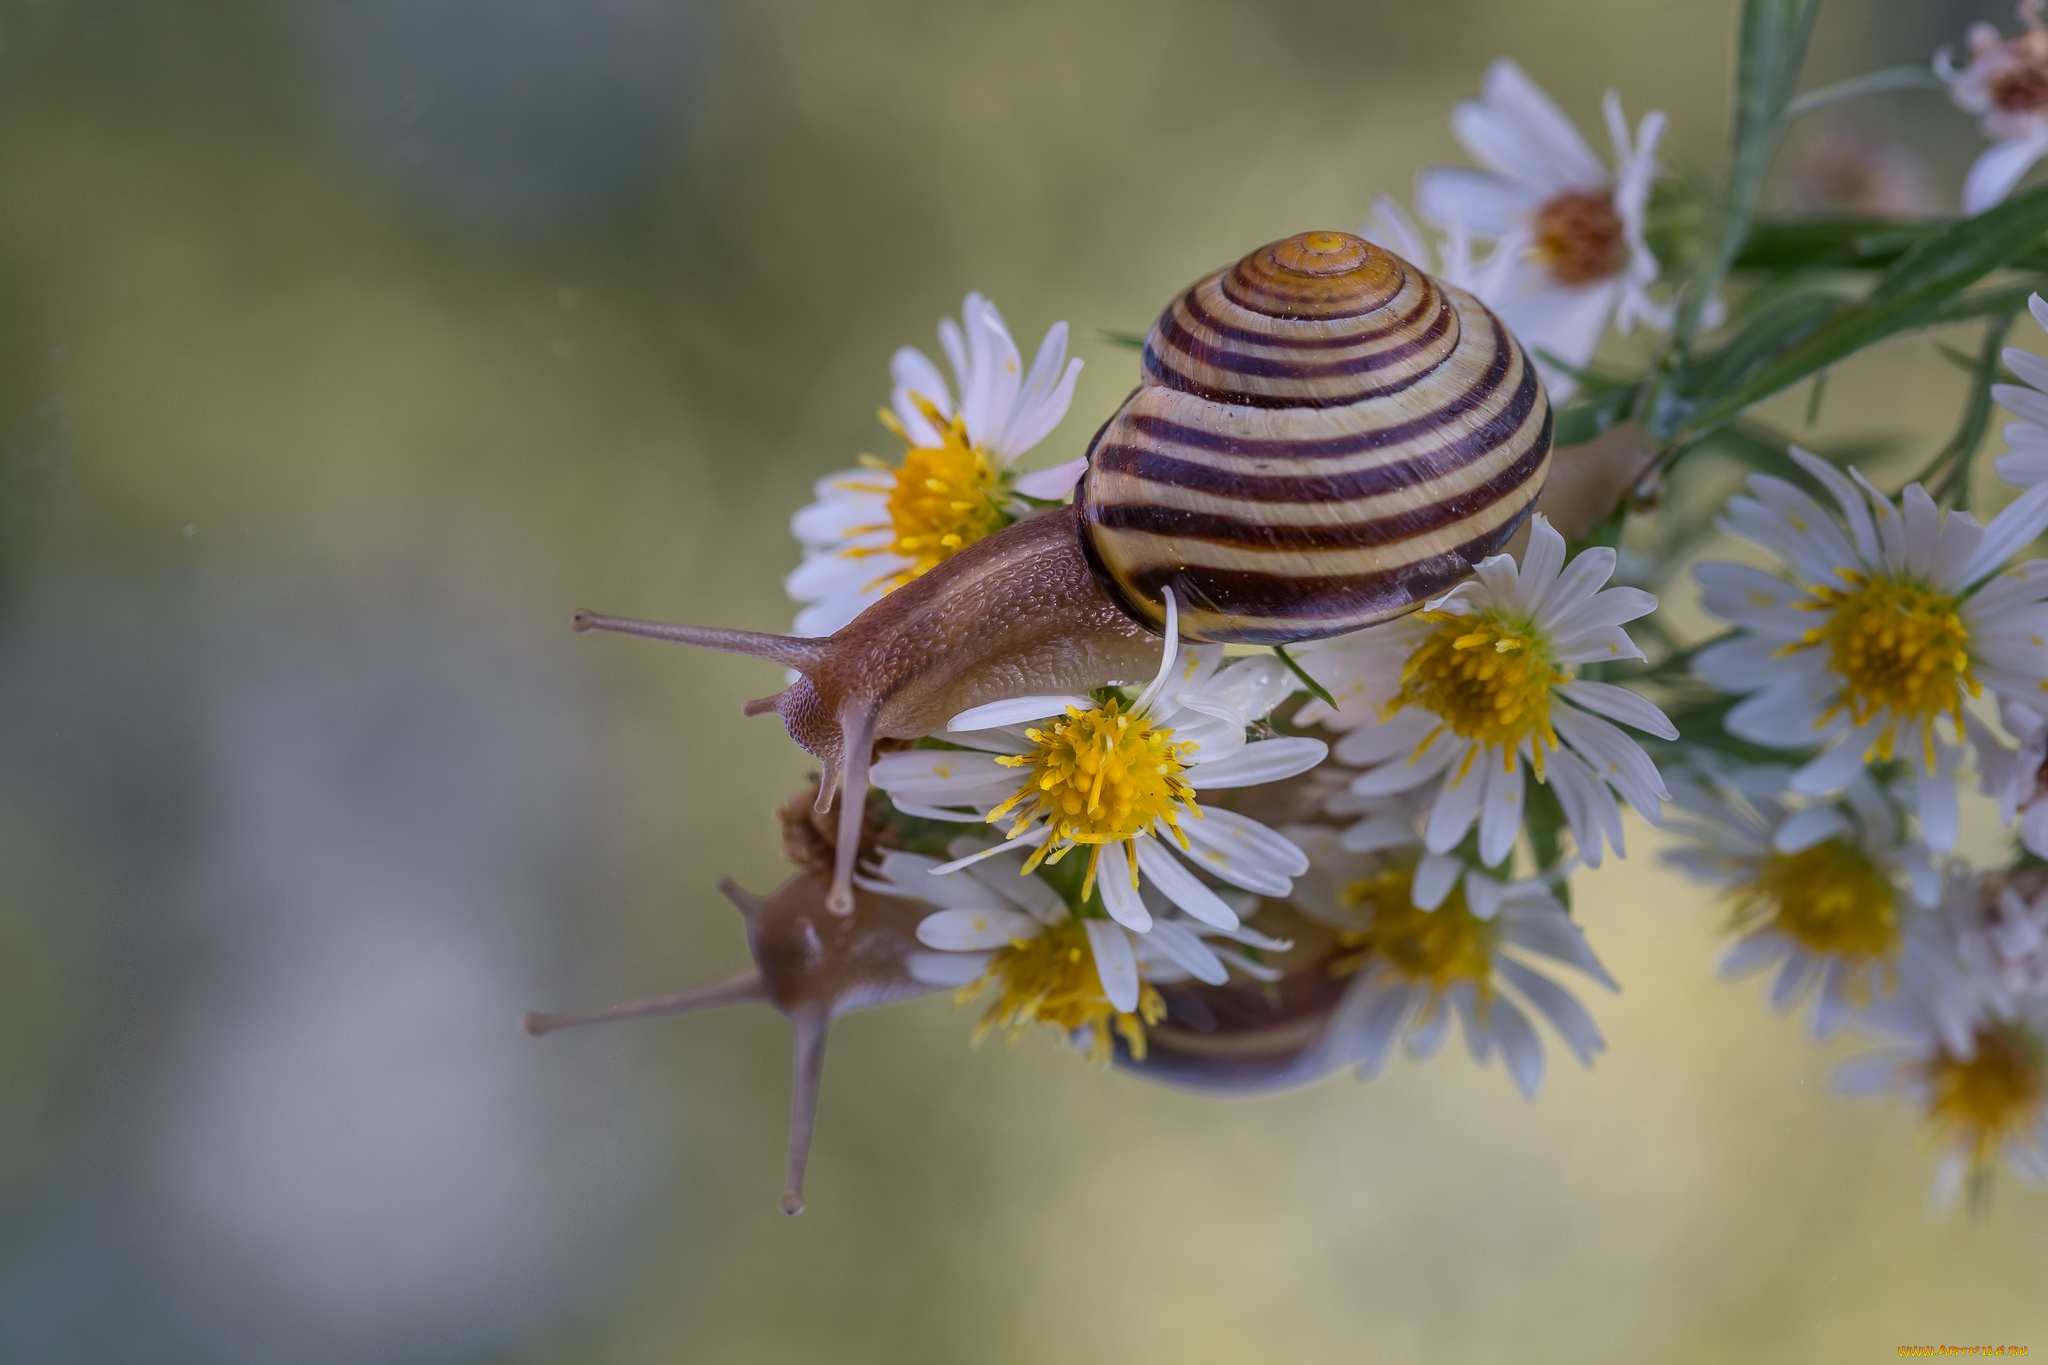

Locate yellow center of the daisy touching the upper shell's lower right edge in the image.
[1386,612,1571,780]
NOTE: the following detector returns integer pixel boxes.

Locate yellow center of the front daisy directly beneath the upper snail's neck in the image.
[989,698,1202,898]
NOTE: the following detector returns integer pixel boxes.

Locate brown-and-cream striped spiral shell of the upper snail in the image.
[1077,231,1550,645]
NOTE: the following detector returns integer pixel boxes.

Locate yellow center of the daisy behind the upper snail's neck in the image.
[846,397,1012,587]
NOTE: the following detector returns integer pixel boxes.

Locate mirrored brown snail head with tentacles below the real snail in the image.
[524,794,938,1214]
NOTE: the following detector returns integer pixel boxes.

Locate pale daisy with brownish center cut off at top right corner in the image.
[1933,0,2048,213]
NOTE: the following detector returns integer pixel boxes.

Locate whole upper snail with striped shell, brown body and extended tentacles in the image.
[575,231,1550,915]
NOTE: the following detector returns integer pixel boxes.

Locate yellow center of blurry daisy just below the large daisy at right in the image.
[1733,839,1898,964]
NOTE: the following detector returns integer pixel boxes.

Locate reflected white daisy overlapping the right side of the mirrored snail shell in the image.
[1290,802,1618,1095]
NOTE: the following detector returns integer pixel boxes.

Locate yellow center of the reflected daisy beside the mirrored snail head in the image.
[958,919,1165,1062]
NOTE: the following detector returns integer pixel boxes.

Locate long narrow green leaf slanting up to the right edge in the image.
[1675,186,2048,436]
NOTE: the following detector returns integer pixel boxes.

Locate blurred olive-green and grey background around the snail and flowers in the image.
[0,0,2048,1365]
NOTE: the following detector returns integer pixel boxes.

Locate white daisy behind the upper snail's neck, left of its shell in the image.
[784,295,1085,634]
